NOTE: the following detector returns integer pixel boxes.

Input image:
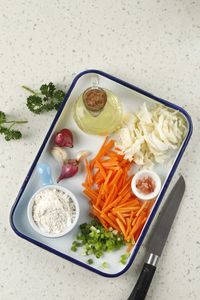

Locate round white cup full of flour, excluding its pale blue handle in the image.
[27,185,80,237]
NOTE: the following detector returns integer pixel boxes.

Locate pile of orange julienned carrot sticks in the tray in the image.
[82,138,153,244]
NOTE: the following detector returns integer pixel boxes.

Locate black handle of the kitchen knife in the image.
[128,263,156,300]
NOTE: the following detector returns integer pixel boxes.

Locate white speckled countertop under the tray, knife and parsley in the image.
[0,0,200,300]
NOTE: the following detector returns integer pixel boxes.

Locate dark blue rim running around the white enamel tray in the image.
[10,69,193,277]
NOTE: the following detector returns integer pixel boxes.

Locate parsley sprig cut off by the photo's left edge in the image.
[0,111,27,141]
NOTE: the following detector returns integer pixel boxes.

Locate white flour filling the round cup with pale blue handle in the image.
[33,188,76,234]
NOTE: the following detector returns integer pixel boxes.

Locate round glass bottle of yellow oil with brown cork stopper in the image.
[74,86,123,135]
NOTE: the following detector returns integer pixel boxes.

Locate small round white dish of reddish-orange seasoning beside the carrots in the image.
[131,170,161,200]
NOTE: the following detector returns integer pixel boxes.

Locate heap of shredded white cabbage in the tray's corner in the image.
[116,103,187,167]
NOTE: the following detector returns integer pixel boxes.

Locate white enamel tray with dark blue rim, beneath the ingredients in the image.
[10,70,192,277]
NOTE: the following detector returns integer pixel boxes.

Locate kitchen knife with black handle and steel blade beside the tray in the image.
[128,176,185,300]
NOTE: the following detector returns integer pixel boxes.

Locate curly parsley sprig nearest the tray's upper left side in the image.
[22,82,65,114]
